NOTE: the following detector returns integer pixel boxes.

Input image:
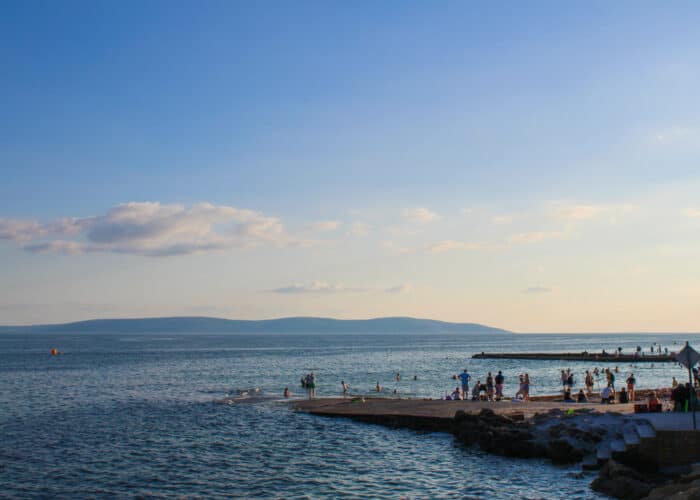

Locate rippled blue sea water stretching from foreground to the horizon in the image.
[0,333,700,498]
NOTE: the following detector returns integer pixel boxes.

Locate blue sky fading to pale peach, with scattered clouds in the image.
[0,1,700,332]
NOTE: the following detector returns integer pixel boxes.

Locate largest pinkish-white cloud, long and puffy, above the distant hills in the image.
[0,202,304,257]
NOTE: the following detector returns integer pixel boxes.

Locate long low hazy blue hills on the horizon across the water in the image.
[0,317,512,334]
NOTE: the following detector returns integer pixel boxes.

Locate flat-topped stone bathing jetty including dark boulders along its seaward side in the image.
[295,399,700,499]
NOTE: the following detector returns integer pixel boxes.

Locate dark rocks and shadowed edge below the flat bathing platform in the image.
[302,407,700,500]
